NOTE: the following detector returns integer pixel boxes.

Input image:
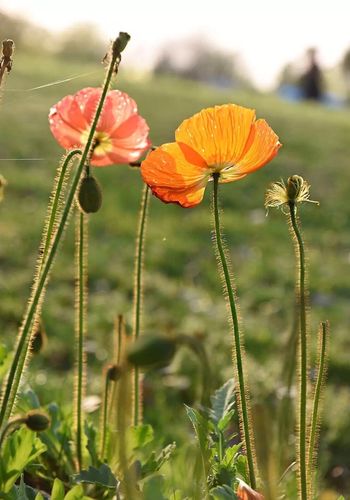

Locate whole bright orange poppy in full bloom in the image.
[141,104,281,207]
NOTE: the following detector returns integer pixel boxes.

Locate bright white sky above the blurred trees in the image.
[0,0,350,88]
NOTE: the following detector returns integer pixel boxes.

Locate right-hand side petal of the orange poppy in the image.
[233,120,282,180]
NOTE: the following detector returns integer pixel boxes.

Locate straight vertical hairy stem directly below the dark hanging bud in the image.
[75,211,88,470]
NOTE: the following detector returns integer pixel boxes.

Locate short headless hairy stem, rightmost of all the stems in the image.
[308,322,328,496]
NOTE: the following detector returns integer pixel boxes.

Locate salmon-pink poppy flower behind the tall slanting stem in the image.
[49,87,151,167]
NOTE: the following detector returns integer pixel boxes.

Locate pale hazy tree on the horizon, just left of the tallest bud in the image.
[58,24,106,62]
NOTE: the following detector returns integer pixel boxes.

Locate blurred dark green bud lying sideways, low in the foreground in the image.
[126,336,177,367]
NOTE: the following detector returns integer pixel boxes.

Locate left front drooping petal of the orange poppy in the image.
[141,142,210,207]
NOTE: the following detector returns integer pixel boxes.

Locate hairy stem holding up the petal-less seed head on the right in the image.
[289,202,308,500]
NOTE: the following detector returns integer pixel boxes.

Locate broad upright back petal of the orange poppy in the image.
[175,104,255,166]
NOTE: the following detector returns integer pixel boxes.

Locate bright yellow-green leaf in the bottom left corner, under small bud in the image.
[0,427,46,493]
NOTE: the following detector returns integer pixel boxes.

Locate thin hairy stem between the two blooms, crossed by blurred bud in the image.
[133,184,149,426]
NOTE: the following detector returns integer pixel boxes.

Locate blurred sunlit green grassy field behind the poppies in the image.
[0,48,350,498]
